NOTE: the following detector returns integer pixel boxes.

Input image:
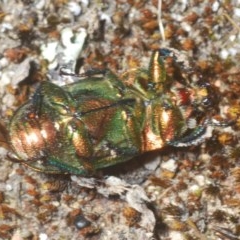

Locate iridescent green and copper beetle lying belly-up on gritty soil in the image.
[9,48,218,175]
